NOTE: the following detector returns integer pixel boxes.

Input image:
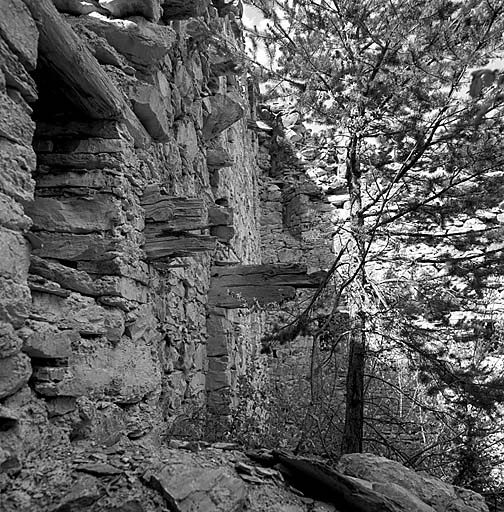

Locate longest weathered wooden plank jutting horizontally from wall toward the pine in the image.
[208,263,325,308]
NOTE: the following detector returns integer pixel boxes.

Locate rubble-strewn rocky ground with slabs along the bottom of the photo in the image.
[0,432,488,512]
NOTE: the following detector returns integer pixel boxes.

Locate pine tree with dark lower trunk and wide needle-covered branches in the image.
[246,0,504,488]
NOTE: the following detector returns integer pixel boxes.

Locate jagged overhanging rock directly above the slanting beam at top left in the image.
[72,13,176,69]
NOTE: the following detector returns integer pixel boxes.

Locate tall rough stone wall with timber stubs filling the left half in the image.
[0,0,270,469]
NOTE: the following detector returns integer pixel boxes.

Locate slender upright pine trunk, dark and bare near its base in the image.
[341,135,366,453]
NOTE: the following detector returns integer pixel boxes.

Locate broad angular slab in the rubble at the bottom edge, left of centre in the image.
[144,464,247,512]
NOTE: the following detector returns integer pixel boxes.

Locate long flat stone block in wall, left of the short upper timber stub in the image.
[26,194,126,233]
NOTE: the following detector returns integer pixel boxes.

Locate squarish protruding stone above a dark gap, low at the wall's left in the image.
[23,324,76,359]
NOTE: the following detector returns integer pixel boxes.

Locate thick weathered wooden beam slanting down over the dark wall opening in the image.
[24,0,150,147]
